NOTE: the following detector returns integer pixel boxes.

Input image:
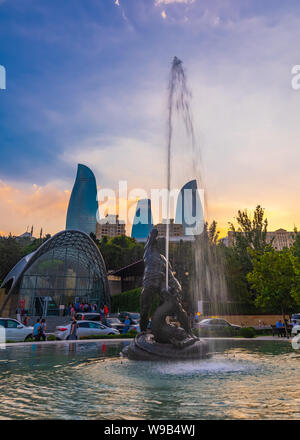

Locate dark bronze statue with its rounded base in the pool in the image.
[123,228,208,360]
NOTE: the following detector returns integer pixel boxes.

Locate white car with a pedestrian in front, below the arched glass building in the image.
[54,320,119,340]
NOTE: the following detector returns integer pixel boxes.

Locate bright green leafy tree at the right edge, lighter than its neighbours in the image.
[247,248,300,334]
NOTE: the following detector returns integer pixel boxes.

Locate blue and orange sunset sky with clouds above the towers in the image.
[0,0,300,235]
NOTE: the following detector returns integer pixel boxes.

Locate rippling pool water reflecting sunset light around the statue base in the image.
[0,340,300,419]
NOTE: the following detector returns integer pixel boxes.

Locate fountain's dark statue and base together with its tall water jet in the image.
[123,57,209,361]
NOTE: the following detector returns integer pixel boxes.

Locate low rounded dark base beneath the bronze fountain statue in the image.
[122,333,210,362]
